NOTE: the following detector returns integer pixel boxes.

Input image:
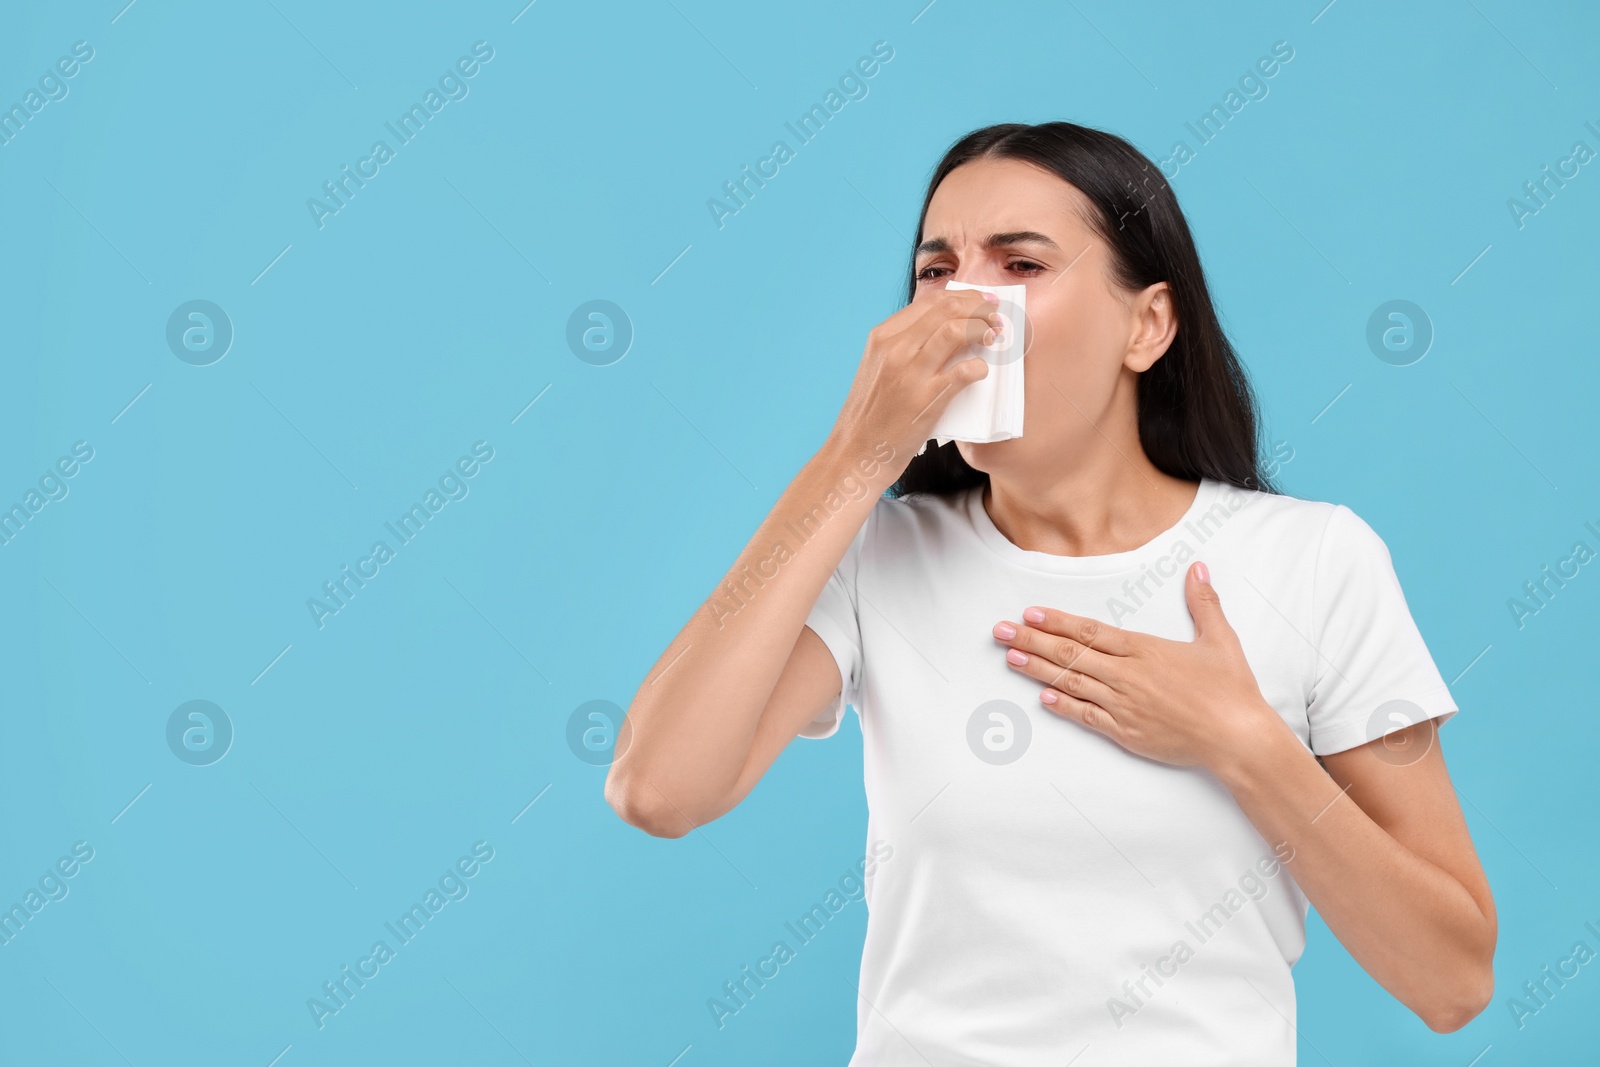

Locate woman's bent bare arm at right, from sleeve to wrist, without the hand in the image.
[1214,709,1498,1033]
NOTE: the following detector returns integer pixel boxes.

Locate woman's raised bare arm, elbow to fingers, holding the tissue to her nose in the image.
[605,290,1003,837]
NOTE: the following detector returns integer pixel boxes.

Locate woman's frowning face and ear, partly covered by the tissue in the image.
[915,160,1176,472]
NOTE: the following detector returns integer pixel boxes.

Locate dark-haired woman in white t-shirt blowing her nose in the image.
[606,123,1496,1067]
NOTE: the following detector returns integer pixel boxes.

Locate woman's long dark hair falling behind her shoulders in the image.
[890,122,1278,496]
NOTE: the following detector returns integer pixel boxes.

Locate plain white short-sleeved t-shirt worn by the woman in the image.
[800,478,1456,1067]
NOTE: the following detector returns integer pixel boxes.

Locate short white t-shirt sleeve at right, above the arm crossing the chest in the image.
[1306,504,1458,755]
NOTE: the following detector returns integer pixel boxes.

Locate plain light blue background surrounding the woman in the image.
[0,0,1600,1067]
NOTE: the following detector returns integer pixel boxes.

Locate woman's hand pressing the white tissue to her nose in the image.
[829,290,1003,485]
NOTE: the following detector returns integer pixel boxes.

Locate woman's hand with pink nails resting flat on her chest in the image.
[994,563,1283,773]
